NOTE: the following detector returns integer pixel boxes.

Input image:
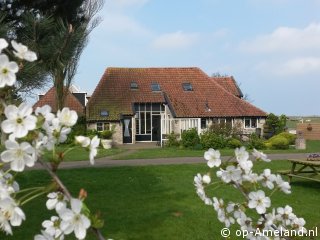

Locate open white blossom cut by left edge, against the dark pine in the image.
[0,54,19,88]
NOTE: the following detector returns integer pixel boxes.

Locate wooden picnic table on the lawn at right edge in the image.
[279,159,320,182]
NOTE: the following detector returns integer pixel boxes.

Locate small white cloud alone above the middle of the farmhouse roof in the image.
[151,31,199,49]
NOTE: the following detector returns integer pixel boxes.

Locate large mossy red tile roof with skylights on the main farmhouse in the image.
[87,68,266,121]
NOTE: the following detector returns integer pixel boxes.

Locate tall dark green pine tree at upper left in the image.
[0,0,103,109]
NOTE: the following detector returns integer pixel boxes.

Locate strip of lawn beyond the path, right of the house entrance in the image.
[115,140,320,159]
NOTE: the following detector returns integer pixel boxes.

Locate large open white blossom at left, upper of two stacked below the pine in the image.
[1,103,37,138]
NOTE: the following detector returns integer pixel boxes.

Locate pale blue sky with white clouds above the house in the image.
[74,0,320,116]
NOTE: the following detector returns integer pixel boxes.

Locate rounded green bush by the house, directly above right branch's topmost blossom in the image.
[200,130,227,149]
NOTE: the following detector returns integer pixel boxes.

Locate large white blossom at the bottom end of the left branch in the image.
[58,198,91,239]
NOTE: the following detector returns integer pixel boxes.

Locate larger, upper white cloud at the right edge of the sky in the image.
[239,23,320,53]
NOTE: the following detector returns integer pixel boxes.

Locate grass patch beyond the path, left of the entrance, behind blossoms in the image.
[43,145,125,162]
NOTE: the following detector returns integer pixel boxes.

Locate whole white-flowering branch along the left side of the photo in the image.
[0,38,105,240]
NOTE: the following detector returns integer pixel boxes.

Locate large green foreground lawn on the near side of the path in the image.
[0,161,320,240]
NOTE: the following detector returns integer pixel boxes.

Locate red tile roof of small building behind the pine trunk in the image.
[33,87,85,115]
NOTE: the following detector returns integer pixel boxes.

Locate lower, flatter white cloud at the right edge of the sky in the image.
[255,57,320,76]
